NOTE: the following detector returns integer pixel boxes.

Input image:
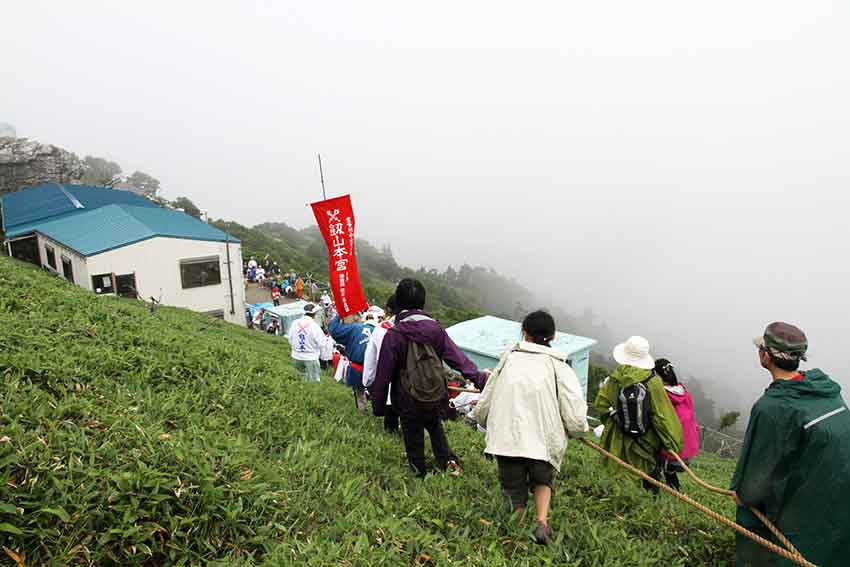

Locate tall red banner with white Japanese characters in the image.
[310,195,369,317]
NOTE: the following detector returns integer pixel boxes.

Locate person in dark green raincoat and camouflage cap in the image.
[731,323,850,567]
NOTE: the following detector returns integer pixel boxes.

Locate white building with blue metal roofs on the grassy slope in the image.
[0,183,245,324]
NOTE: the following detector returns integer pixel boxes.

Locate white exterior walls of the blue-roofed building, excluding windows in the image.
[84,237,245,325]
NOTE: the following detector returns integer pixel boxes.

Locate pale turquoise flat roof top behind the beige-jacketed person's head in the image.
[446,315,596,360]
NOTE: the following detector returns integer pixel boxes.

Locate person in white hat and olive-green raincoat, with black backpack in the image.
[593,337,682,493]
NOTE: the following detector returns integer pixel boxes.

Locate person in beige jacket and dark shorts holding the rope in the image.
[470,311,589,545]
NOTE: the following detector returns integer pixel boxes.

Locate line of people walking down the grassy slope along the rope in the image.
[282,279,850,567]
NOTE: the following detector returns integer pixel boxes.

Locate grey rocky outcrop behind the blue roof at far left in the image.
[0,137,84,193]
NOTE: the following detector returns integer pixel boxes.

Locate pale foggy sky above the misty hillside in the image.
[0,1,850,408]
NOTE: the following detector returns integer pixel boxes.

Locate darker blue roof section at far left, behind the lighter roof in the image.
[0,183,158,236]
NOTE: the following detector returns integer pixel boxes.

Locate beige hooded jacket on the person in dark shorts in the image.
[470,341,589,471]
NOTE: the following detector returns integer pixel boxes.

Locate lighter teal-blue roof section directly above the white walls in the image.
[14,205,239,256]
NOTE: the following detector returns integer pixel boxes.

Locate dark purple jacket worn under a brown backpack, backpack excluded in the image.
[371,309,486,417]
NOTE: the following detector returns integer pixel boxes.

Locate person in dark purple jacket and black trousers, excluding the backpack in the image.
[372,279,489,477]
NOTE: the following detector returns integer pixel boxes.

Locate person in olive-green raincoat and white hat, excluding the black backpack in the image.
[593,337,682,492]
